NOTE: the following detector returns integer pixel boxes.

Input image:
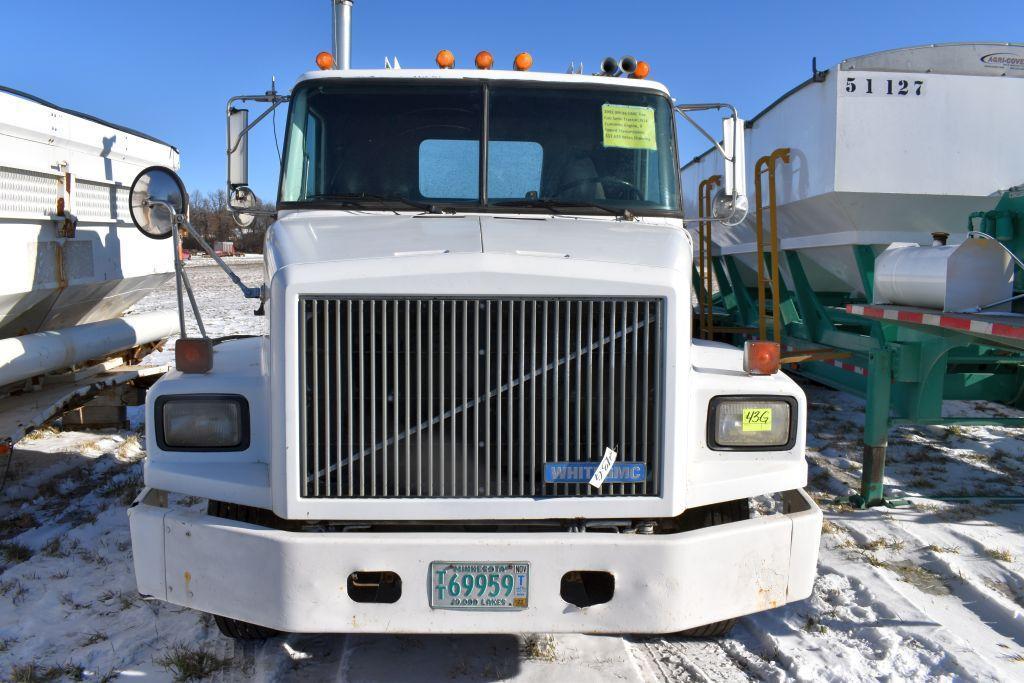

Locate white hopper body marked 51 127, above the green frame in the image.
[683,43,1024,295]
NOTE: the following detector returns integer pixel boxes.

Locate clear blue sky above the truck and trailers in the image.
[0,0,1024,200]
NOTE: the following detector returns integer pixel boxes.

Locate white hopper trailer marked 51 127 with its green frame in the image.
[683,43,1024,504]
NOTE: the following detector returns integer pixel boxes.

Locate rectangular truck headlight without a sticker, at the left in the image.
[156,394,249,451]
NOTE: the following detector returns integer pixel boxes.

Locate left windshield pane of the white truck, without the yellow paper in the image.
[282,81,483,203]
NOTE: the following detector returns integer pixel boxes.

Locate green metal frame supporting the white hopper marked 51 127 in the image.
[694,187,1024,507]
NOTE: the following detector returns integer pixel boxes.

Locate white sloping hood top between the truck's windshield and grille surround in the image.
[266,211,691,276]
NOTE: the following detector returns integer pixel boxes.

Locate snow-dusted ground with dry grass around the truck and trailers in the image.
[0,264,1024,681]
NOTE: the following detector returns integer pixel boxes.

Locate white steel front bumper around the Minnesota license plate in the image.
[128,488,821,633]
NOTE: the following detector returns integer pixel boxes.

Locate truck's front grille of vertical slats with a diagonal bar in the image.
[299,297,665,499]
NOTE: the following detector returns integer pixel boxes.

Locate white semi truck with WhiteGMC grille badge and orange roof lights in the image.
[123,0,821,638]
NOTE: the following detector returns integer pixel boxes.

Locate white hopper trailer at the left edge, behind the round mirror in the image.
[0,87,178,450]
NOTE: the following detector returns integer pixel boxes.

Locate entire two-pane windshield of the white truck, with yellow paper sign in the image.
[281,81,679,215]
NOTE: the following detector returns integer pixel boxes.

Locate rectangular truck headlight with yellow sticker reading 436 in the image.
[708,396,797,451]
